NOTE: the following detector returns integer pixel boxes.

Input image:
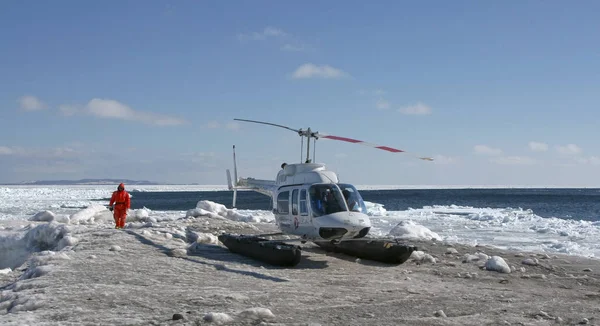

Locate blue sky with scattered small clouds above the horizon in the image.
[0,0,600,187]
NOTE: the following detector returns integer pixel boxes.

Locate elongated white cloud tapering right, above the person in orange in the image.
[85,98,185,126]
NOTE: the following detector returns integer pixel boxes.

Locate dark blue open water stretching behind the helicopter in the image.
[117,188,600,221]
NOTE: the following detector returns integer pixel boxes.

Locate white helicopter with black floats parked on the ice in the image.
[220,119,433,265]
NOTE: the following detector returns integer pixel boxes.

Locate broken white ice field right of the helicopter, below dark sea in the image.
[370,205,600,257]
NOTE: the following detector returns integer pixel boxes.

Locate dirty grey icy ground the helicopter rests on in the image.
[0,217,600,325]
